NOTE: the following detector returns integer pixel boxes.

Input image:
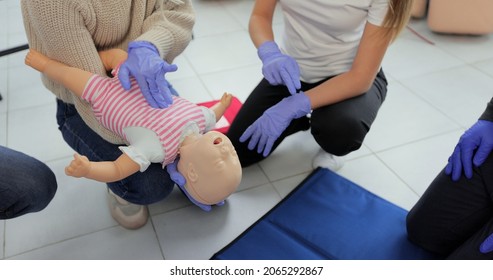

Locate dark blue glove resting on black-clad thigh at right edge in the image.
[445,120,493,181]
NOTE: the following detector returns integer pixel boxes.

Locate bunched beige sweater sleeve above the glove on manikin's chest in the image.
[136,0,195,63]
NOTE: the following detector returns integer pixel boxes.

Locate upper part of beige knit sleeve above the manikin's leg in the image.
[22,0,105,79]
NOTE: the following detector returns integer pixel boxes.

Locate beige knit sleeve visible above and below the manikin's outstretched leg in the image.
[21,0,125,144]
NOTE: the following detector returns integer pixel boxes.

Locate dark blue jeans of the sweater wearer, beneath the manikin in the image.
[57,100,174,205]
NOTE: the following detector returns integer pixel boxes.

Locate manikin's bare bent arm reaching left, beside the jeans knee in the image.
[65,154,140,183]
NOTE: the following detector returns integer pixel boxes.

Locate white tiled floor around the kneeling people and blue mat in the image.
[0,0,493,259]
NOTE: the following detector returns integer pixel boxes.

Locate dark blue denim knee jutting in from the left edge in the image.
[0,146,57,219]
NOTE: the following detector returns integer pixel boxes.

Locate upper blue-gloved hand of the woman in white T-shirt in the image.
[257,41,301,94]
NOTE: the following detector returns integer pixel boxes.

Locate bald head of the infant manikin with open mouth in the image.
[178,131,242,205]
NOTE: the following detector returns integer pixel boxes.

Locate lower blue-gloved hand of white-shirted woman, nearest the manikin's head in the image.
[240,92,311,157]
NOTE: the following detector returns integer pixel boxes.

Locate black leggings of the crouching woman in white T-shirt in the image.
[228,70,387,167]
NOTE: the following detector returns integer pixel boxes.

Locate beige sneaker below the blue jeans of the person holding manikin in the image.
[108,189,149,229]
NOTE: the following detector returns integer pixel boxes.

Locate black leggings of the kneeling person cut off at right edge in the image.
[407,154,493,259]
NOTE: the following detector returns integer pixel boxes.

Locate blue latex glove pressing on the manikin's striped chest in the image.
[118,41,178,108]
